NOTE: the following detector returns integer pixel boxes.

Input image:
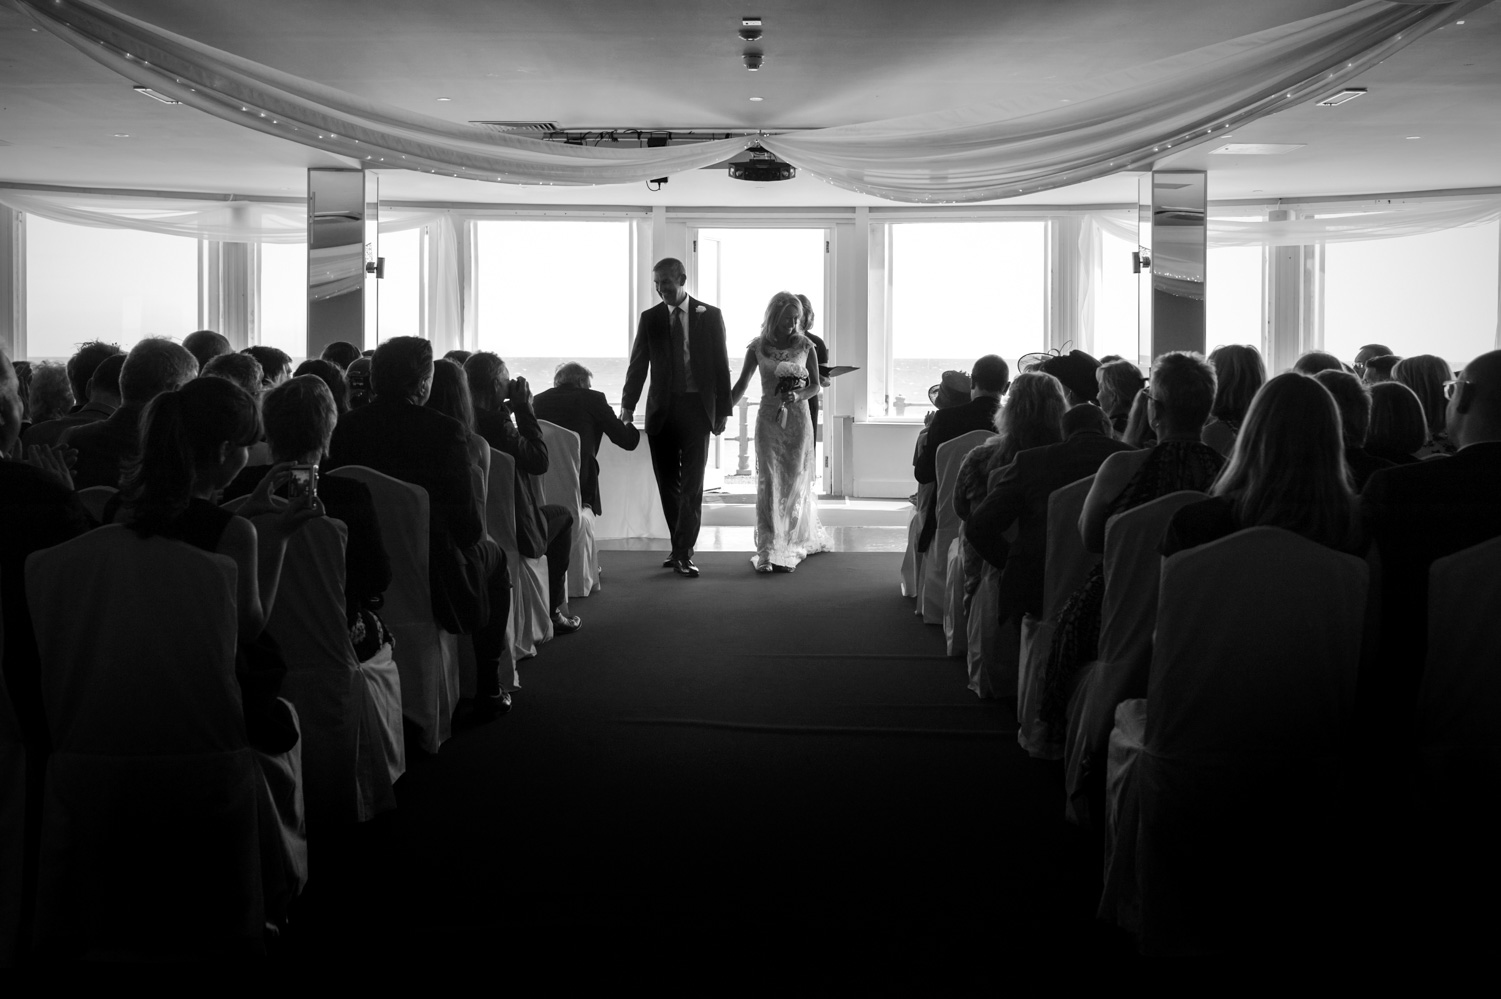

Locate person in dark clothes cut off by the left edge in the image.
[0,350,92,750]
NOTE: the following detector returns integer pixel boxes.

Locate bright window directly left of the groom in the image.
[474,219,635,402]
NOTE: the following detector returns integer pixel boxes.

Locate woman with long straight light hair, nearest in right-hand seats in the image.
[1162,369,1363,555]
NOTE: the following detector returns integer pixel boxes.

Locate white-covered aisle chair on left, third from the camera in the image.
[331,465,459,753]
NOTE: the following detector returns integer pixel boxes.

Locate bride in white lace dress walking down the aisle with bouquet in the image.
[729,291,829,573]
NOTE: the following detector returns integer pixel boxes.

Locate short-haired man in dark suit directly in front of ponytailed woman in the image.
[62,336,198,489]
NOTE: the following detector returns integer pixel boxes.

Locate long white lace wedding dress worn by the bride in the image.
[751,335,829,572]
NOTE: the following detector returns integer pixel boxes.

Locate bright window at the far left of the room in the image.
[26,215,198,360]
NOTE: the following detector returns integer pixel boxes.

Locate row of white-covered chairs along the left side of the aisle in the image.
[0,423,599,966]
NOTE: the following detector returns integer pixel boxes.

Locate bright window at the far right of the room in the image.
[1324,222,1498,369]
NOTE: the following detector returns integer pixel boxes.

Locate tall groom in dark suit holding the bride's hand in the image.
[620,257,732,578]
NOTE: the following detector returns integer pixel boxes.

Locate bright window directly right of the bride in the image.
[871,221,1048,419]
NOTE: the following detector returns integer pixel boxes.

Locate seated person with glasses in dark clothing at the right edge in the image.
[1360,351,1501,711]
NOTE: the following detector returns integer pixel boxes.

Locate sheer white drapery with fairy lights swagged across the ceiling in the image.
[8,0,1489,203]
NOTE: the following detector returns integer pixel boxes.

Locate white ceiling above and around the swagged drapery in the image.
[0,0,1501,207]
